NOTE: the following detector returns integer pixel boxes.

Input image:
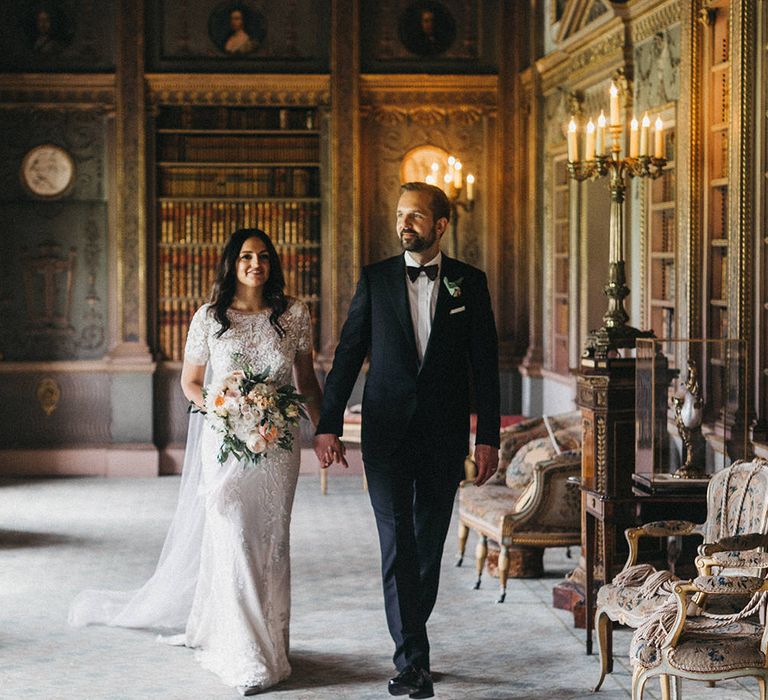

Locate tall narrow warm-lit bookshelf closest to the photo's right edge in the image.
[702,0,731,412]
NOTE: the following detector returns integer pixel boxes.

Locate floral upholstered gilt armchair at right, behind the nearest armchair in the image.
[595,459,768,691]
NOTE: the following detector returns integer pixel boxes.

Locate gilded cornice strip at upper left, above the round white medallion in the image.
[0,73,115,111]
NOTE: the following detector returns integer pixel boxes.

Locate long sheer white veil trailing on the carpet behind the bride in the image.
[69,396,210,632]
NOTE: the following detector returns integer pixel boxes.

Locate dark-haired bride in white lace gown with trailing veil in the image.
[69,229,328,695]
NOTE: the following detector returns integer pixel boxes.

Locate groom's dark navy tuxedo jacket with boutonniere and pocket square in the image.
[317,255,499,457]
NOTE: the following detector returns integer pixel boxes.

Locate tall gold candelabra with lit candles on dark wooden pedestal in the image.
[568,84,667,362]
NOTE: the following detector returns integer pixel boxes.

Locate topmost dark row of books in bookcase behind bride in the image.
[156,105,317,130]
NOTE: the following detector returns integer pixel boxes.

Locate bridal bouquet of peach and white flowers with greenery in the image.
[203,358,307,465]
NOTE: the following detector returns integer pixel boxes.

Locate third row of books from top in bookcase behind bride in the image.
[157,166,320,197]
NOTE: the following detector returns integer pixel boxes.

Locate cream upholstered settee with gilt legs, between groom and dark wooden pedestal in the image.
[457,413,581,603]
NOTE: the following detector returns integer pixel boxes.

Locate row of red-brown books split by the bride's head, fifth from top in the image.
[157,245,320,300]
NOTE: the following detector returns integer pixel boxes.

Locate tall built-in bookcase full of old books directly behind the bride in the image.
[155,106,321,362]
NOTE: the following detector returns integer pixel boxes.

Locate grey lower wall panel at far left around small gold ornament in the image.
[0,372,111,449]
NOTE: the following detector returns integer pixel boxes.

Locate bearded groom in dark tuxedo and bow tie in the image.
[315,182,499,698]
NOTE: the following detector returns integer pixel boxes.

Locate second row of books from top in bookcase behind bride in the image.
[157,134,320,163]
